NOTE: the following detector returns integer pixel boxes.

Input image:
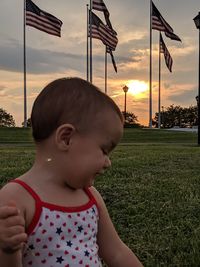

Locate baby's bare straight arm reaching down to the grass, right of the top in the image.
[92,188,143,267]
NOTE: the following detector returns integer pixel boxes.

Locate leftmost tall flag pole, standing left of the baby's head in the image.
[24,0,27,127]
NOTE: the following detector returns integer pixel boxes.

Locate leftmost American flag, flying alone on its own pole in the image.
[26,0,62,37]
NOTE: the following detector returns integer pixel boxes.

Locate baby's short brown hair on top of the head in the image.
[31,77,123,142]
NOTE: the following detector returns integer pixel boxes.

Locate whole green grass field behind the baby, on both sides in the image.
[0,128,200,267]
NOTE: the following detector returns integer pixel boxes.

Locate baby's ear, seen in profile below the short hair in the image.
[55,123,75,150]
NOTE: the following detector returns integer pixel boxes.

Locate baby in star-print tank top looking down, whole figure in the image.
[0,78,142,267]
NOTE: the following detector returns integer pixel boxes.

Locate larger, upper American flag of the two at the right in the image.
[151,1,181,41]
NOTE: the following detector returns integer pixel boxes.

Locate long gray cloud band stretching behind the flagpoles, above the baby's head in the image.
[0,39,139,74]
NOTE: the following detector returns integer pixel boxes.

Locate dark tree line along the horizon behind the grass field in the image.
[0,104,198,128]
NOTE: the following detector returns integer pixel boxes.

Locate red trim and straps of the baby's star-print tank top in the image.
[10,179,98,235]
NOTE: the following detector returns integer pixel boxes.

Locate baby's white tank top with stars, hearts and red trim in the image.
[12,179,102,267]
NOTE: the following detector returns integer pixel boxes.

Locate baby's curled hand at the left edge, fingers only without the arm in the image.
[0,202,27,253]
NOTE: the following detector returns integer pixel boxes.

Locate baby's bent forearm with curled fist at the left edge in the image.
[0,186,27,267]
